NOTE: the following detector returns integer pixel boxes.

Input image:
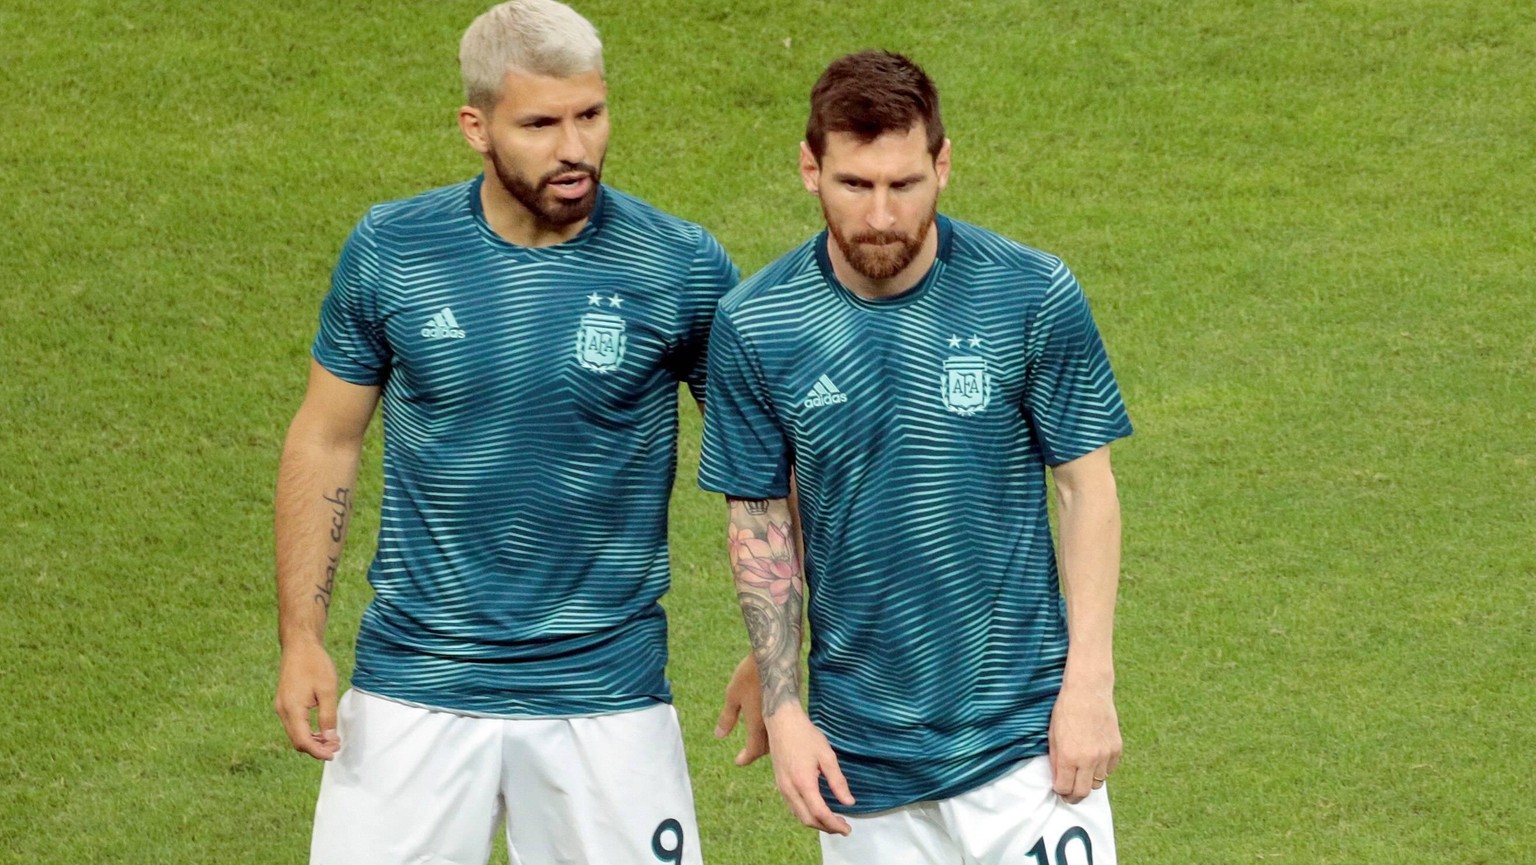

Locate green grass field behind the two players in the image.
[0,0,1536,865]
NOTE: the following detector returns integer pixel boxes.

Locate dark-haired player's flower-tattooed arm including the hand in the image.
[728,498,854,834]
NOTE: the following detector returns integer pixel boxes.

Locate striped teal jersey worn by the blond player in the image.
[313,178,737,718]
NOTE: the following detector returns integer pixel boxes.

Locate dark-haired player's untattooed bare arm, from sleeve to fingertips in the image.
[1051,447,1121,802]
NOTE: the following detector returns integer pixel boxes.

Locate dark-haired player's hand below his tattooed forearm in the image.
[766,702,854,834]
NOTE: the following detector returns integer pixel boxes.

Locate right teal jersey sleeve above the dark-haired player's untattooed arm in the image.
[1025,264,1130,466]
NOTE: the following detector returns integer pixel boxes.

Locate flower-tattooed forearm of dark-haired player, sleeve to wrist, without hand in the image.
[730,499,805,718]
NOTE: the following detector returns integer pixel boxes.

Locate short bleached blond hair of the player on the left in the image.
[459,0,602,111]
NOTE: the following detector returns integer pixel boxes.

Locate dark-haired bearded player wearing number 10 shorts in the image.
[700,52,1130,865]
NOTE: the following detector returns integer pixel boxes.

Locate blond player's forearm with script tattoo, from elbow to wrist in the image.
[273,433,361,645]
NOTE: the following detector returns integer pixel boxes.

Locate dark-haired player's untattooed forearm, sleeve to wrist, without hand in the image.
[1057,455,1120,687]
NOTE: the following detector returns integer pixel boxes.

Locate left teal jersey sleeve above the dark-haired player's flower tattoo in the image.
[699,312,790,499]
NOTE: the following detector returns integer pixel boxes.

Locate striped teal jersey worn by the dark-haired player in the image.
[699,217,1130,813]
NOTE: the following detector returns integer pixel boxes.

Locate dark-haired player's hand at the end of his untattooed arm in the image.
[1049,684,1123,804]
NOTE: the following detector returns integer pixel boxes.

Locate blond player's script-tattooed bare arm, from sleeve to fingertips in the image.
[273,361,379,759]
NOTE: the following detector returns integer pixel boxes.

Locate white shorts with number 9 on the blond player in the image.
[310,690,702,865]
